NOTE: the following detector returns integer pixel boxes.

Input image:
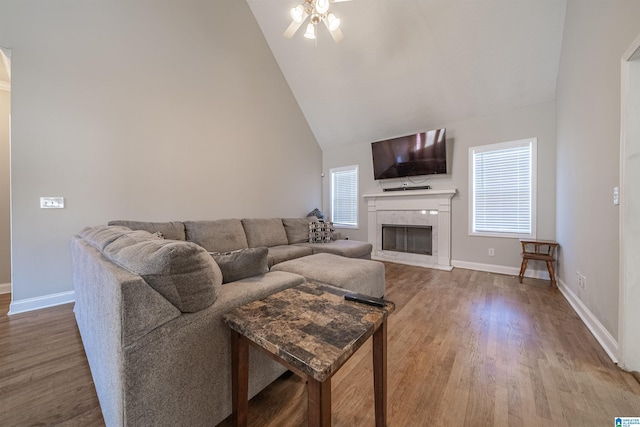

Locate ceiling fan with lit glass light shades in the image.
[283,0,351,43]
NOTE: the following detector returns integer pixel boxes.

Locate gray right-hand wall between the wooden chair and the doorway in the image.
[557,0,640,339]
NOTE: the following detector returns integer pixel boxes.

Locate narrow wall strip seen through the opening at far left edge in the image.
[0,90,11,285]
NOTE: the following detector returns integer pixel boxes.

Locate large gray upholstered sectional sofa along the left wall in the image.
[71,218,384,426]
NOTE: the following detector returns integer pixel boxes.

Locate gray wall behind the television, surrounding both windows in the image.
[323,102,556,271]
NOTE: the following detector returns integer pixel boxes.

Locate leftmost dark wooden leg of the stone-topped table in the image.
[231,331,249,427]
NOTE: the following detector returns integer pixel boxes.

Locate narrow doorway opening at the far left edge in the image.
[0,47,11,293]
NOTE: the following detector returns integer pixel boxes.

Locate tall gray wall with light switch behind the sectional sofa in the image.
[0,0,322,302]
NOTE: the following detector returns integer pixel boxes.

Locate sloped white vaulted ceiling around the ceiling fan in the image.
[247,0,566,149]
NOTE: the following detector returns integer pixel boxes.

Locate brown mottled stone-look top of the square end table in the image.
[223,282,395,381]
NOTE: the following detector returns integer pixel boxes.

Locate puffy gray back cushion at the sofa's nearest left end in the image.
[104,231,222,313]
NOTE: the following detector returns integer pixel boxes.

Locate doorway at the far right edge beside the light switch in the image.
[618,36,640,374]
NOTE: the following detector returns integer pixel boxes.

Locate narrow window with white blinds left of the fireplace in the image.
[330,166,358,228]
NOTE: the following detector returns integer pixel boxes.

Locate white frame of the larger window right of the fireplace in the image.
[468,137,538,239]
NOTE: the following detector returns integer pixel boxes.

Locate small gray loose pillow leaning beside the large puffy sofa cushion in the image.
[211,246,269,283]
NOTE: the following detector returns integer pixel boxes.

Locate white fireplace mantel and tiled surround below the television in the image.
[364,190,456,271]
